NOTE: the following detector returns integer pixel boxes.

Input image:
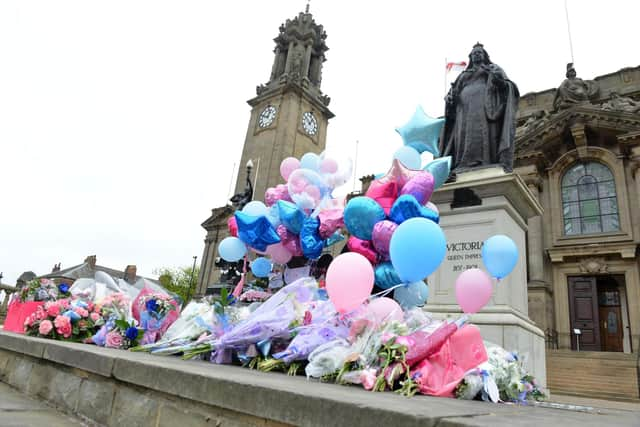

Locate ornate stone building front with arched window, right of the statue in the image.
[514,64,640,353]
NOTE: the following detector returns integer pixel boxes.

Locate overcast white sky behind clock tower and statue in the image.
[0,0,640,284]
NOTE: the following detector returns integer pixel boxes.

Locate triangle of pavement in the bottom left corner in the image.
[0,382,88,427]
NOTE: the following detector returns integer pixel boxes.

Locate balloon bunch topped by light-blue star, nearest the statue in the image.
[338,107,451,308]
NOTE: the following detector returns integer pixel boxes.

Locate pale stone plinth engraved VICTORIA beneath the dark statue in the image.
[426,168,546,384]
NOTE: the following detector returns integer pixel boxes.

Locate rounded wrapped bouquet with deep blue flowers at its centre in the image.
[131,288,180,345]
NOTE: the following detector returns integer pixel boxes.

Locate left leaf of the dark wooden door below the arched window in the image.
[569,277,601,351]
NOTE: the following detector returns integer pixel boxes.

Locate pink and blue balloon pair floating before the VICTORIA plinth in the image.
[455,235,518,314]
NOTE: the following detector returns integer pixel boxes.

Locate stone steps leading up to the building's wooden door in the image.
[547,350,640,401]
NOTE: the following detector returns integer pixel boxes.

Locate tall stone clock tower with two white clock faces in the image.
[235,5,333,200]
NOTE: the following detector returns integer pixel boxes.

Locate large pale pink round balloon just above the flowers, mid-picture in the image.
[326,252,373,313]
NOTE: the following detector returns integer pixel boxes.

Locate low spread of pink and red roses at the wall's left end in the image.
[25,298,100,342]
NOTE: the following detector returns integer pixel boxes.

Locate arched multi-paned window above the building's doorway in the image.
[562,162,620,235]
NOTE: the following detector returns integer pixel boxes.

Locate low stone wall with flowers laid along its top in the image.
[0,332,637,427]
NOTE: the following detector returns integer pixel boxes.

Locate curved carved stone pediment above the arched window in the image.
[515,104,640,160]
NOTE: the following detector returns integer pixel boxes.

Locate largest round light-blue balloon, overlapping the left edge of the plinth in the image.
[389,218,447,283]
